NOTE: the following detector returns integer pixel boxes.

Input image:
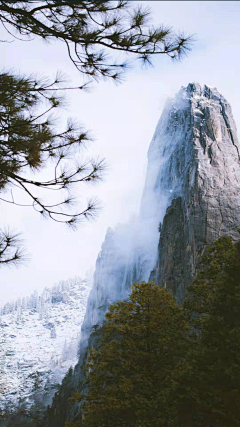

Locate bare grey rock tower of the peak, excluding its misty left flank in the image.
[153,84,240,302]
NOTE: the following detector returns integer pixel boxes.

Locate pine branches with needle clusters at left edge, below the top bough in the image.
[0,73,104,265]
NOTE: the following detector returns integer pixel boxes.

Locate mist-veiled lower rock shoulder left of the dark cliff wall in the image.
[80,219,158,349]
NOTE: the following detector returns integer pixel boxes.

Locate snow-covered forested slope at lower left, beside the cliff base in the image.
[0,278,91,414]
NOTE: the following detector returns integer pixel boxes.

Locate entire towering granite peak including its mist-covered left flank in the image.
[46,83,240,427]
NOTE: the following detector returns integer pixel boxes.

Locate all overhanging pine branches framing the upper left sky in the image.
[0,0,192,264]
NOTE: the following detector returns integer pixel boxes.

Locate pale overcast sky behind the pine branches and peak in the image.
[0,1,240,305]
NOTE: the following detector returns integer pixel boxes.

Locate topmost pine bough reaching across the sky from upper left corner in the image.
[0,0,191,80]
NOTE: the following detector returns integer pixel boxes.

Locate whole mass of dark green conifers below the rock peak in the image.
[68,237,240,427]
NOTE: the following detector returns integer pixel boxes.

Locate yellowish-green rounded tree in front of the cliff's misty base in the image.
[69,282,190,427]
